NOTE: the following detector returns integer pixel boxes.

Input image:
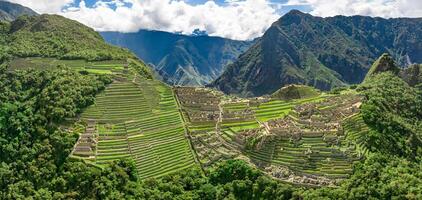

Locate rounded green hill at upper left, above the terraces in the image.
[0,14,135,60]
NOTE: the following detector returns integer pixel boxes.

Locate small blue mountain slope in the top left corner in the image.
[0,1,38,21]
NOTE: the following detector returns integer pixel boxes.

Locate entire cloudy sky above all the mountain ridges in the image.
[8,0,422,40]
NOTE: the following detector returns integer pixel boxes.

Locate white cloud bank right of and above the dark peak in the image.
[283,0,422,18]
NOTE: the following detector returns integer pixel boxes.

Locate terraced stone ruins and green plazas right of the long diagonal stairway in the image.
[175,87,367,185]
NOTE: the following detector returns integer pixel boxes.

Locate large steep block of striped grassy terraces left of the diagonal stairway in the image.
[81,77,195,178]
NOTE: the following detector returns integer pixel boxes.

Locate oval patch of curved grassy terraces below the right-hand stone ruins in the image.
[247,137,353,178]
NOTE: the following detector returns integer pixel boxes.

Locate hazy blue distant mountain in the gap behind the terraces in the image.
[101,30,252,86]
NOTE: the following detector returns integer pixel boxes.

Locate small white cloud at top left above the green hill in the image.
[8,0,74,13]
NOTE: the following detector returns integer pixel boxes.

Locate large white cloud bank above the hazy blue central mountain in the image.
[60,0,280,40]
